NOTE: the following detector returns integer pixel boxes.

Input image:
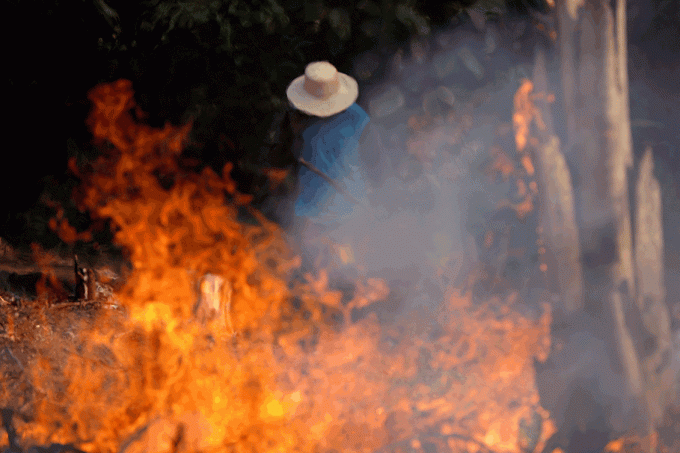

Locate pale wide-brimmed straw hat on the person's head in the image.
[286,61,359,117]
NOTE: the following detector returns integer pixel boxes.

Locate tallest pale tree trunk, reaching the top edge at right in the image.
[559,0,643,420]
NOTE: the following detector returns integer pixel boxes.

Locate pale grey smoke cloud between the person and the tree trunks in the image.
[270,23,535,328]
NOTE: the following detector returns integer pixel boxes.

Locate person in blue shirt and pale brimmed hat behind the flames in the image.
[286,61,378,267]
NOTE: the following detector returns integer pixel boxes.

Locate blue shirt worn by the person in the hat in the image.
[295,103,370,226]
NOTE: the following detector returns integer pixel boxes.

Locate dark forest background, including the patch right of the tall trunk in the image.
[0,0,680,251]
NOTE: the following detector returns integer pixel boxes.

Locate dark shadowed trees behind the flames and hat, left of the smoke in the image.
[6,0,668,244]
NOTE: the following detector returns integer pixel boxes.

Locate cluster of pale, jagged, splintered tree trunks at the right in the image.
[534,0,673,451]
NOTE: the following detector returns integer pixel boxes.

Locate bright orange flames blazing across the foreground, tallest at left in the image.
[9,81,554,453]
